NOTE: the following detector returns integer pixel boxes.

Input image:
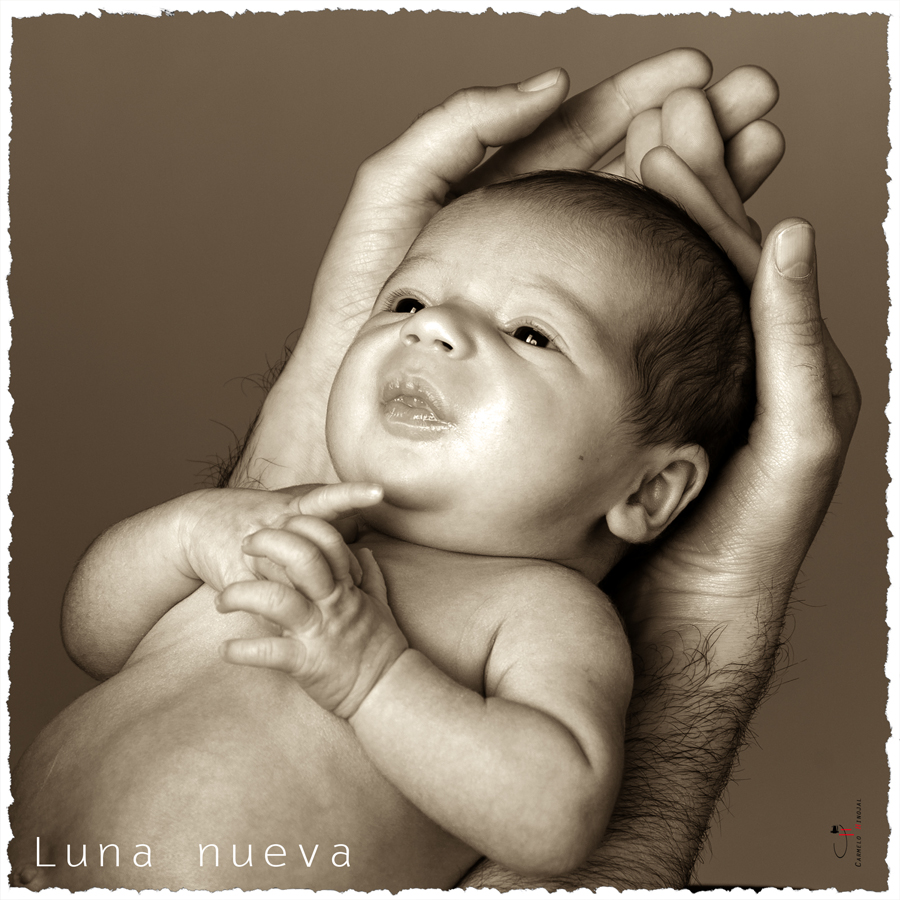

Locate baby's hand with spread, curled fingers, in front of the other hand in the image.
[216,516,408,718]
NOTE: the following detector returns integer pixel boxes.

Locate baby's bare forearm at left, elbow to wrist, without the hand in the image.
[62,498,200,679]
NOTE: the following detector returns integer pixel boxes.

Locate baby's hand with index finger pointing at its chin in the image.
[179,483,383,591]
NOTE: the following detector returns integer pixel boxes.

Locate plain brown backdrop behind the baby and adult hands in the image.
[10,10,888,890]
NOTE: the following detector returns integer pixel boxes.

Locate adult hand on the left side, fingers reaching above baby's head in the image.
[231,49,780,488]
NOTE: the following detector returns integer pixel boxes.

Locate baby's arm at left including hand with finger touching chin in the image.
[62,484,381,679]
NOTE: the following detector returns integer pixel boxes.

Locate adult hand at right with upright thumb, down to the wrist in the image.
[631,148,860,632]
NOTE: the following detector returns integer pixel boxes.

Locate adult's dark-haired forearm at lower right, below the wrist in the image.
[461,591,788,890]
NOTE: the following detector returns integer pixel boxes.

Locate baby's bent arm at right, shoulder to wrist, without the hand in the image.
[350,565,632,875]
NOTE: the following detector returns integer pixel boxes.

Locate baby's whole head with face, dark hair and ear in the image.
[328,172,754,576]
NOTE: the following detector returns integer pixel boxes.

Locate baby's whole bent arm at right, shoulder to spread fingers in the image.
[219,523,632,874]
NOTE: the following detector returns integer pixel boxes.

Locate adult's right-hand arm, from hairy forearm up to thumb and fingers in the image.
[463,172,860,890]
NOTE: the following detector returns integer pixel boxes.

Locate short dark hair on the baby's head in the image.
[467,170,756,471]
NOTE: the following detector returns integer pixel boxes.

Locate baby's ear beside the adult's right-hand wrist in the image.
[606,444,709,544]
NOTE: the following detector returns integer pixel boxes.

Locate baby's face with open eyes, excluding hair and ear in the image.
[327,198,656,559]
